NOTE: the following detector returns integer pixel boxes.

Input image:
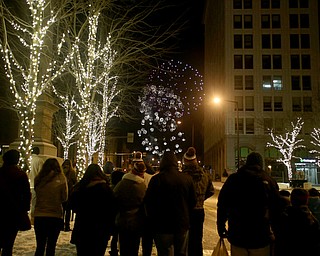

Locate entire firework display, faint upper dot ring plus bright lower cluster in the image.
[138,60,204,155]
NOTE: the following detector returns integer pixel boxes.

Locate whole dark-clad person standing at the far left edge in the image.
[0,149,31,256]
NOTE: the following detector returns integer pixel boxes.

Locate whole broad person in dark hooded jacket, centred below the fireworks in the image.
[145,151,196,256]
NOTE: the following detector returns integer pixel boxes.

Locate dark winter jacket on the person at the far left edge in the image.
[0,165,31,231]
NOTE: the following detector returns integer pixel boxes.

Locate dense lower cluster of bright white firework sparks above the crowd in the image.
[138,85,184,156]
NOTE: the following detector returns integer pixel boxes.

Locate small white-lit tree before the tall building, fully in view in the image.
[267,118,305,179]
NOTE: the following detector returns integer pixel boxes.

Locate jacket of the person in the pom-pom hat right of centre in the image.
[182,164,214,209]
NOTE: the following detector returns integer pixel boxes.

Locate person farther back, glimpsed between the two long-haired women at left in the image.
[62,159,77,232]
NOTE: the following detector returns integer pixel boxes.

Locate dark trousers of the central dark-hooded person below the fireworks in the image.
[154,231,189,256]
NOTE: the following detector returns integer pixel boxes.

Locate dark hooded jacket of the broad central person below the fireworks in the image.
[145,154,196,234]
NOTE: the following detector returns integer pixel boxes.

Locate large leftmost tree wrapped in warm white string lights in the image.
[0,0,72,170]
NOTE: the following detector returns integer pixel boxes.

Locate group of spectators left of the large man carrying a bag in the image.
[0,147,214,256]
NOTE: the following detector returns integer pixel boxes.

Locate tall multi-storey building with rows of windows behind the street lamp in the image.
[204,0,320,183]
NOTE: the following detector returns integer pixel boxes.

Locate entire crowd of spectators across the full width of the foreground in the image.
[0,147,320,256]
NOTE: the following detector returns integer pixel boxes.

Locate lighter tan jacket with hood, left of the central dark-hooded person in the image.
[114,173,147,233]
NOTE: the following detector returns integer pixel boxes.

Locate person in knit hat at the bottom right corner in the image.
[275,188,320,256]
